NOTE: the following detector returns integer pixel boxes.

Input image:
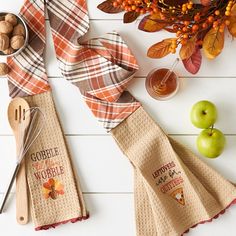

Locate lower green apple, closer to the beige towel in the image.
[197,129,226,158]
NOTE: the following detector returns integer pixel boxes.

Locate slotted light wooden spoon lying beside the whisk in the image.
[8,98,30,225]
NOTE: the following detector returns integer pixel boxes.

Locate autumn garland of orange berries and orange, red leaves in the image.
[98,0,236,74]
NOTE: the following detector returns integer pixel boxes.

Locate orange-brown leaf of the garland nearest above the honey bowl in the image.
[147,38,172,58]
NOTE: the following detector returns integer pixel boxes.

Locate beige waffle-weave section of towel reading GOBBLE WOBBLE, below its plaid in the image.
[25,92,88,230]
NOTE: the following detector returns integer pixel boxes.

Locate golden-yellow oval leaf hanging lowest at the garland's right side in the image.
[203,28,224,59]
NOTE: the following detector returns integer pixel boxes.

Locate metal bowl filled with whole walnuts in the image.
[0,12,28,57]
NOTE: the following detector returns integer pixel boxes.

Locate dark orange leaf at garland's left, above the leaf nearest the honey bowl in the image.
[138,12,169,32]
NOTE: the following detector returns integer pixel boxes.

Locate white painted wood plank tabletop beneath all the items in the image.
[0,0,236,236]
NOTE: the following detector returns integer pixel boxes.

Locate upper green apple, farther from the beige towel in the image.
[191,101,217,129]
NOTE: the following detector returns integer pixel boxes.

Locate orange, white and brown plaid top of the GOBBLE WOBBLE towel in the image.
[8,0,50,97]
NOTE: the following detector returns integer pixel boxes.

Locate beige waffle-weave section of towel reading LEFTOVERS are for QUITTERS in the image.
[111,107,236,236]
